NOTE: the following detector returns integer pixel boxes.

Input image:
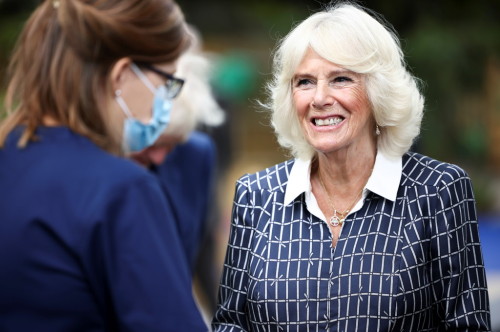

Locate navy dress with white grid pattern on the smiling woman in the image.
[213,153,490,332]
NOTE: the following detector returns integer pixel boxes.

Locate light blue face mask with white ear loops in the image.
[115,64,172,152]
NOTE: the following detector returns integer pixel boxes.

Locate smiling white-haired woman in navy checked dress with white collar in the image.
[213,3,490,332]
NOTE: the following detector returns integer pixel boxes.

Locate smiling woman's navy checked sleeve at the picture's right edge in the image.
[430,166,491,331]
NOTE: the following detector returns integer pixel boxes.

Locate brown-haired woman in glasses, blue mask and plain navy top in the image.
[0,0,207,332]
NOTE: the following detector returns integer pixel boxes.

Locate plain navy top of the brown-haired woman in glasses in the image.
[0,127,207,332]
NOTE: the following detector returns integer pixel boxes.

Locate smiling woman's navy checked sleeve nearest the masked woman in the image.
[212,175,254,332]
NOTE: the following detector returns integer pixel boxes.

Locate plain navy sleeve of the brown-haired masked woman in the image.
[87,174,208,332]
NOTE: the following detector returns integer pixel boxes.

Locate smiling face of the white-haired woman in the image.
[292,49,375,154]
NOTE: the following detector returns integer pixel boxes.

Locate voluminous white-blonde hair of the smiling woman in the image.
[264,2,424,160]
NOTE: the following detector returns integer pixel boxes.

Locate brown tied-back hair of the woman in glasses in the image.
[0,0,190,152]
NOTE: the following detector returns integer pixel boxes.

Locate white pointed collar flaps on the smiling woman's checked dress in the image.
[284,152,403,206]
